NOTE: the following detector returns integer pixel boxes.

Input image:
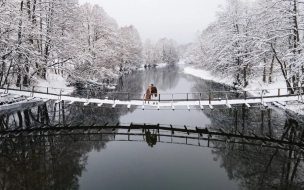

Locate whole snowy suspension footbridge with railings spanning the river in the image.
[0,86,303,110]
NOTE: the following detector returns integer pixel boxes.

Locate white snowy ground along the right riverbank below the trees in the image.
[184,66,304,115]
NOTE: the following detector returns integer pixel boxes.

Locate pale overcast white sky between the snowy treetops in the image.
[79,0,226,44]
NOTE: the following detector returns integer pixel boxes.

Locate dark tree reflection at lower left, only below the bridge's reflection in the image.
[0,137,88,190]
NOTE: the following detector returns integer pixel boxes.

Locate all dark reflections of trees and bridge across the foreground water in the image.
[0,98,303,189]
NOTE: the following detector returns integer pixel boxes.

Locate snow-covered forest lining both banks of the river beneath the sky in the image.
[0,0,304,94]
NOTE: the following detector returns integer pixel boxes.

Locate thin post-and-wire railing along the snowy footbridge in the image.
[1,85,303,102]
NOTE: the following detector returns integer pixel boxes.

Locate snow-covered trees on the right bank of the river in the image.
[182,0,304,94]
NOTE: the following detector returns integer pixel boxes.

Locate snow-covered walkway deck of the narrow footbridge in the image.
[0,88,302,110]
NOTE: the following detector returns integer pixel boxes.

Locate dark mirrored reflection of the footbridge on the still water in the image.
[0,123,304,150]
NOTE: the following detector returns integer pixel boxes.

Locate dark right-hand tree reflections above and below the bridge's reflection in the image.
[206,104,304,189]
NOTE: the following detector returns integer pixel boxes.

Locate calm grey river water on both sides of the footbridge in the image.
[0,66,304,190]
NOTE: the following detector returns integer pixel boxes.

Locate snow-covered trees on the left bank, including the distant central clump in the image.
[0,0,178,87]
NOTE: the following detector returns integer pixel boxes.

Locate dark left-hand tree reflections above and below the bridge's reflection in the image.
[0,101,127,190]
